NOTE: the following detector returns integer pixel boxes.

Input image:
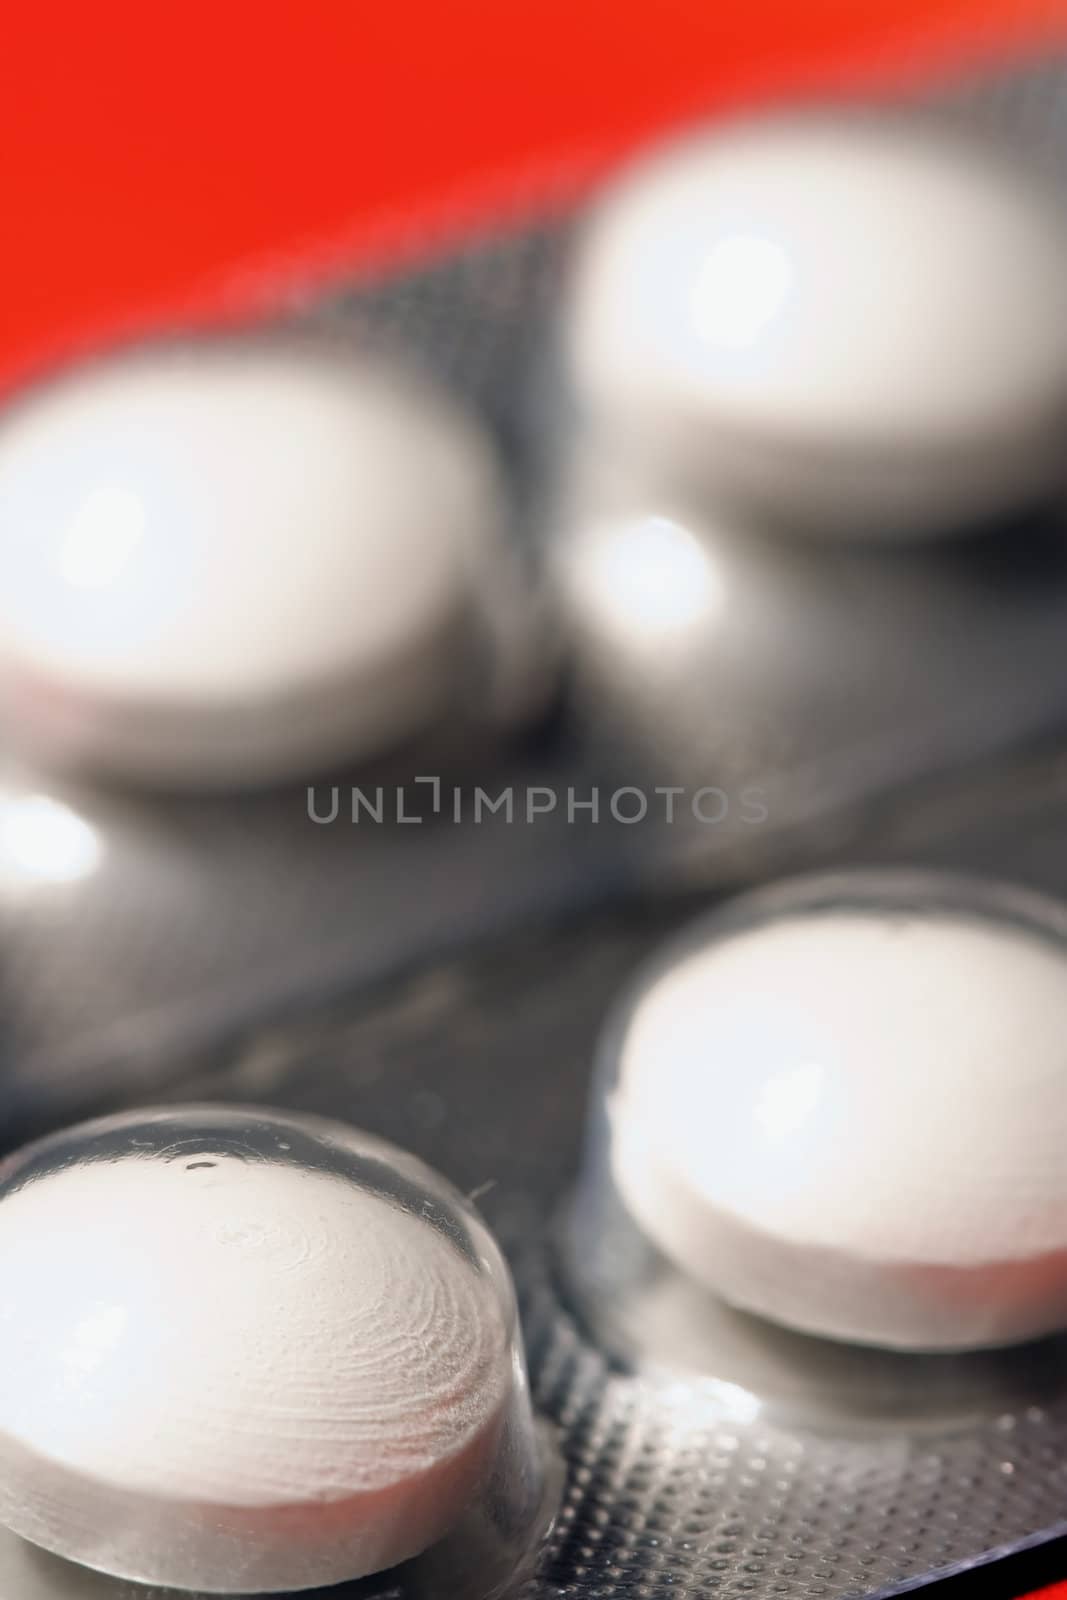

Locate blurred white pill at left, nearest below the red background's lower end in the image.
[0,336,515,784]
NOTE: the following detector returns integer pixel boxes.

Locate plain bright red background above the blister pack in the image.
[0,0,1067,395]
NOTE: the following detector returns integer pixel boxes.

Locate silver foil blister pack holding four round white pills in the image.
[0,18,1067,1600]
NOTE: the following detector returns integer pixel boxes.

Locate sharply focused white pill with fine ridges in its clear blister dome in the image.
[0,1107,544,1594]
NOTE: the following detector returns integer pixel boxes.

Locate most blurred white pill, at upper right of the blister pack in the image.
[568,112,1067,538]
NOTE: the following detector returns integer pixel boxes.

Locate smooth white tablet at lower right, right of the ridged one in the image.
[609,875,1067,1350]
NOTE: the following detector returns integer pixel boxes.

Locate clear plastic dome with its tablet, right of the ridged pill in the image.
[563,870,1067,1424]
